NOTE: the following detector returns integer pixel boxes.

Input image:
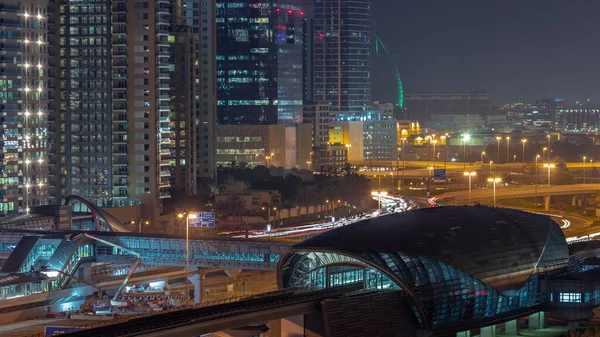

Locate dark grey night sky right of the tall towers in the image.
[373,0,600,105]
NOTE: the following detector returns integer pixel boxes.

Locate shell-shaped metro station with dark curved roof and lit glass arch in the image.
[278,207,593,333]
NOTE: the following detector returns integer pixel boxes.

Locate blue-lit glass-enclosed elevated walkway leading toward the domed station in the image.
[0,229,291,300]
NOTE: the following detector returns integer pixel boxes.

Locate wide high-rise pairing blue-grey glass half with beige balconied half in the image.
[50,0,179,218]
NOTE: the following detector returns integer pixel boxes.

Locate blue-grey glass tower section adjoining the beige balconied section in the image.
[50,0,112,206]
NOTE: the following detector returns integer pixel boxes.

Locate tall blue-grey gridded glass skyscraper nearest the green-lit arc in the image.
[313,0,373,120]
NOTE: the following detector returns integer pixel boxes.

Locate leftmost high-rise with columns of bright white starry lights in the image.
[0,0,48,216]
